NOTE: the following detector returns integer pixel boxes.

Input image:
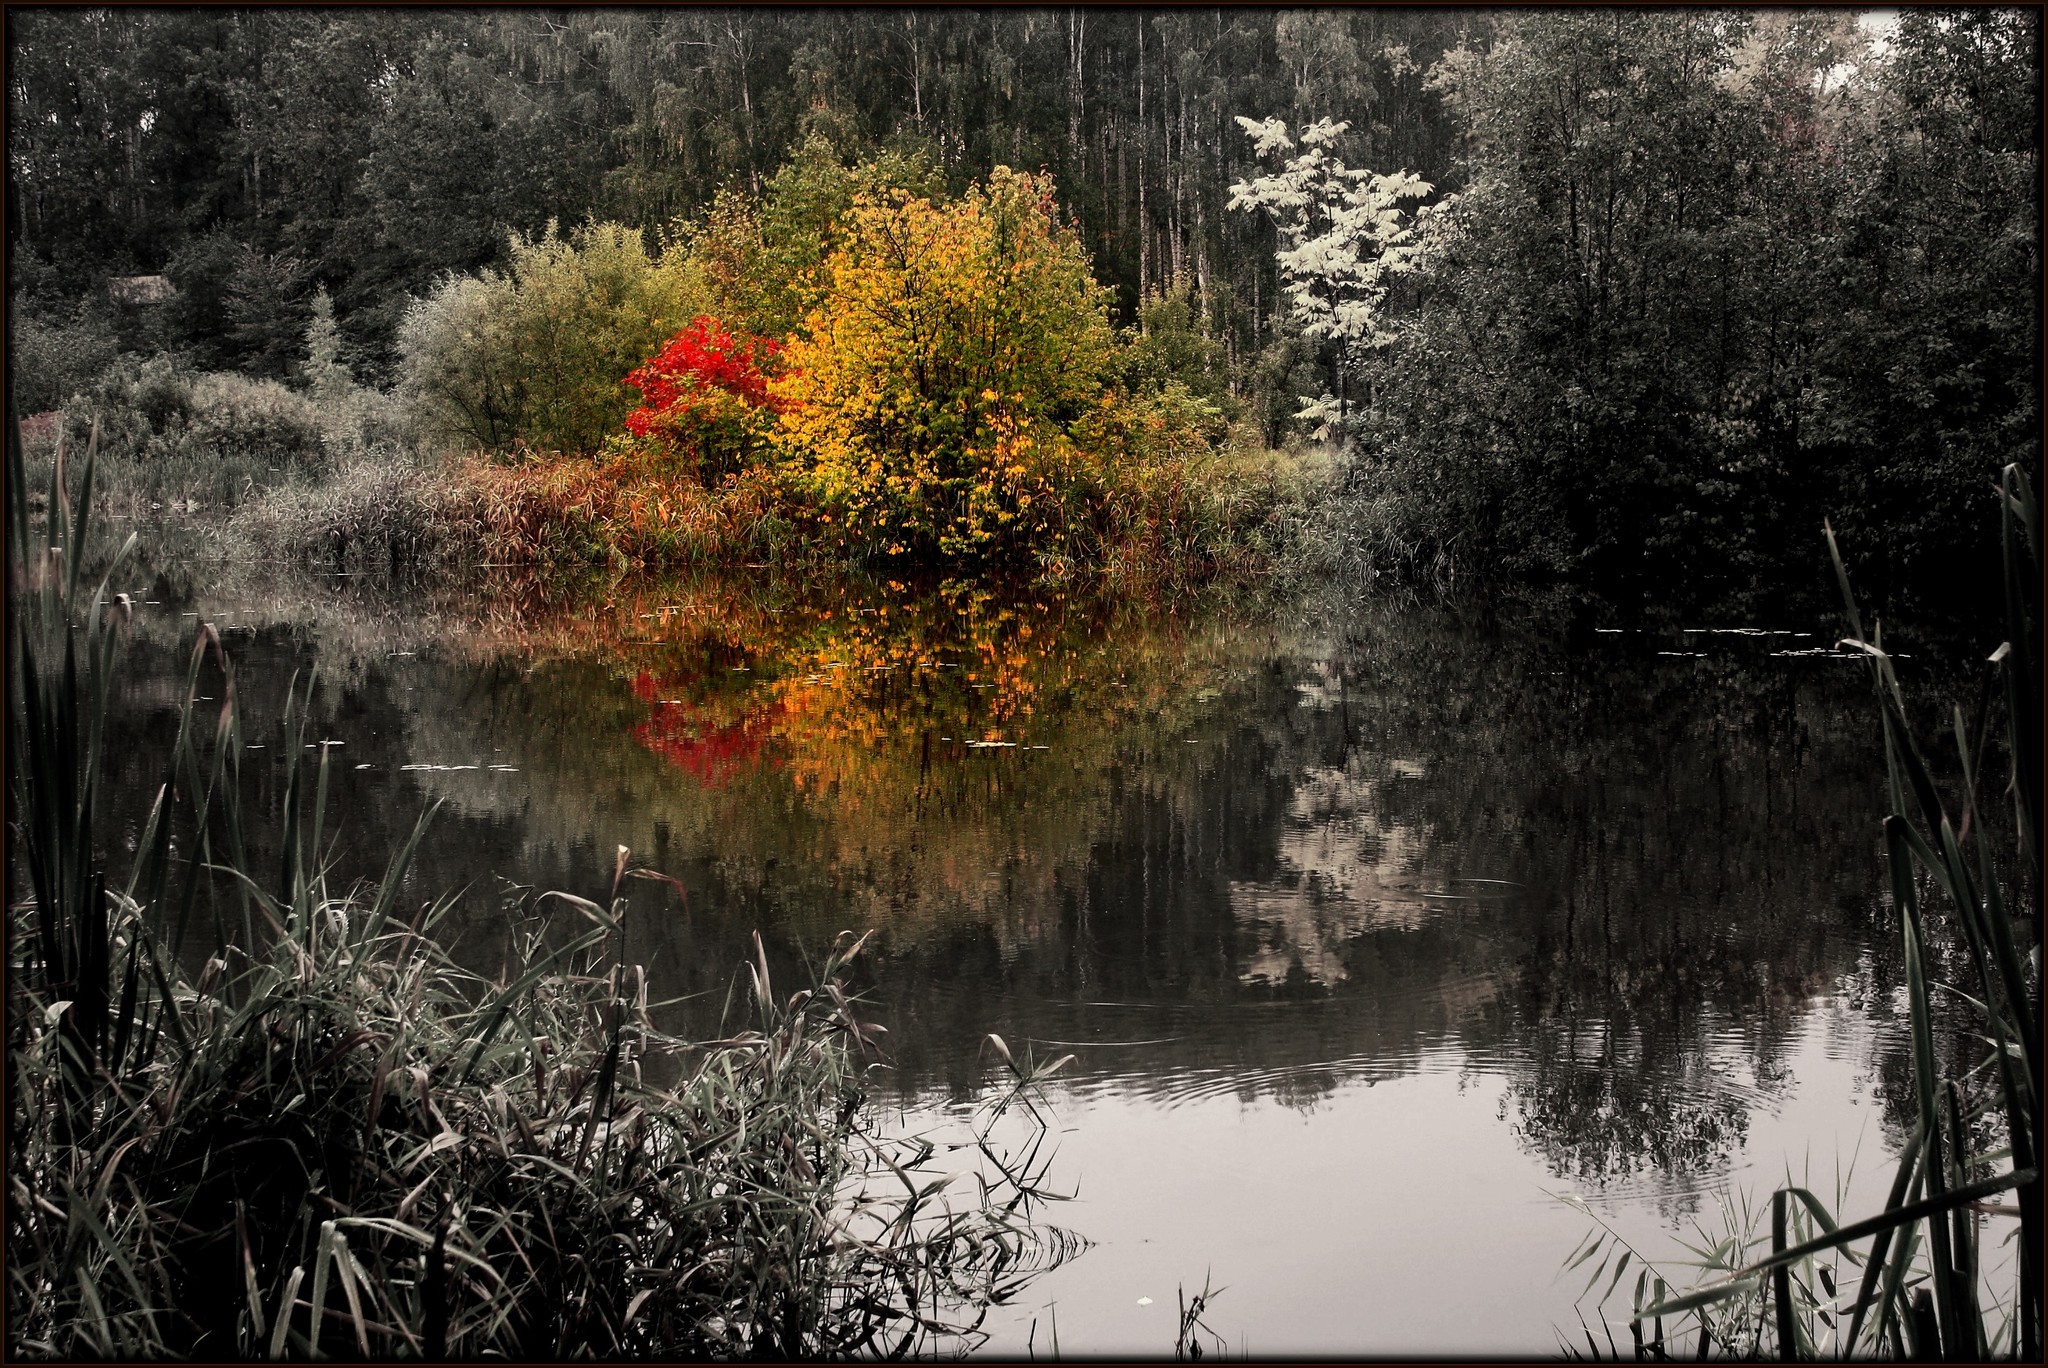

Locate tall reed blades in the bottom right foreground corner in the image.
[1571,465,2044,1362]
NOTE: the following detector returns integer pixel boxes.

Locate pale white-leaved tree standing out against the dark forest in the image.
[1231,117,1442,440]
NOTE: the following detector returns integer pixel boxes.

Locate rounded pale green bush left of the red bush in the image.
[399,223,709,453]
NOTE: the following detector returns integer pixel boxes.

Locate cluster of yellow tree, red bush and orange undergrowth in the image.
[465,160,1278,588]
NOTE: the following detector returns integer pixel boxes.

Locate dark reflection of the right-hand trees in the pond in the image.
[1318,597,1882,1182]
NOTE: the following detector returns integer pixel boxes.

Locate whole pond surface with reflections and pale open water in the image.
[92,569,1933,1356]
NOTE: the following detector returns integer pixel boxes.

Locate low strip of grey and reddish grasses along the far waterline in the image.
[16,409,1343,598]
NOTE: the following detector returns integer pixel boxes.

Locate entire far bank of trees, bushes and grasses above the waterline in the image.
[8,10,2040,606]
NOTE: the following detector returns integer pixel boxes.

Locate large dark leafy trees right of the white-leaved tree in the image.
[1364,10,2040,596]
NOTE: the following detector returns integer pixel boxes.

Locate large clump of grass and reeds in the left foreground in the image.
[6,417,1057,1360]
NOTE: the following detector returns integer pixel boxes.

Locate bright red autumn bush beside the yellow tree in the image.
[625,313,782,485]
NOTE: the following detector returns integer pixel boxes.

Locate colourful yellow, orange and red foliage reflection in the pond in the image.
[446,582,1235,922]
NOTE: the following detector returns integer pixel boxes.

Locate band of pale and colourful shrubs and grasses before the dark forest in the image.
[27,139,1333,598]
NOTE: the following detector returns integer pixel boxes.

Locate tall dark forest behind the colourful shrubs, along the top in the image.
[8,6,1489,383]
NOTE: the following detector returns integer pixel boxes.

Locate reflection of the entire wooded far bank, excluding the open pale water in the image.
[103,565,1890,1228]
